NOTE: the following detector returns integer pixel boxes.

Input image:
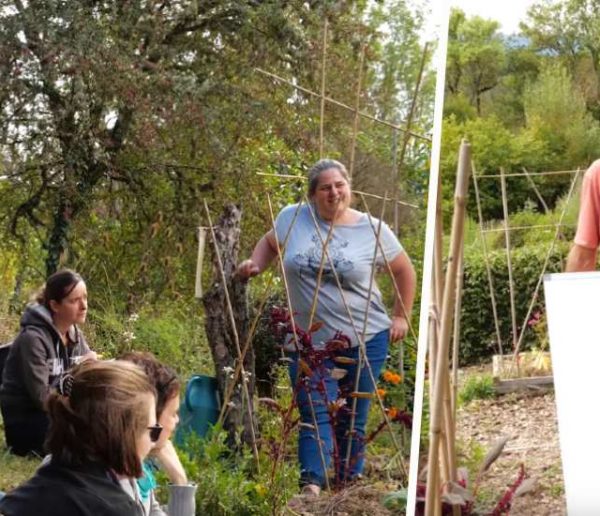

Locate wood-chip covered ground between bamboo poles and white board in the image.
[457,391,566,516]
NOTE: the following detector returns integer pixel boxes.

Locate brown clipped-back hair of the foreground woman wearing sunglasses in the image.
[46,360,155,478]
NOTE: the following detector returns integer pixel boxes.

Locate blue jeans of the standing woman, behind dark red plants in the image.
[289,330,389,486]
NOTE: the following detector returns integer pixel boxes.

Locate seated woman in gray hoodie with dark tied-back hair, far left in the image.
[0,269,96,455]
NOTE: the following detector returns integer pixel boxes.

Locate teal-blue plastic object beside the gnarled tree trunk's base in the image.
[175,374,220,446]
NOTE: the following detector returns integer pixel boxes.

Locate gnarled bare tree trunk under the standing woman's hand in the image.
[202,204,257,445]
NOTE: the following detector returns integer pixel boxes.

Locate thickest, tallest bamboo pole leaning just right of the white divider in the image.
[425,140,471,516]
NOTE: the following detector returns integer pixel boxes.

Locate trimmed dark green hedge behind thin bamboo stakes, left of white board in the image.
[460,242,569,365]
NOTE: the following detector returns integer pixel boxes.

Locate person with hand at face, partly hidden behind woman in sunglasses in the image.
[121,352,197,516]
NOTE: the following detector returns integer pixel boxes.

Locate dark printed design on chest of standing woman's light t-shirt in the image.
[294,233,354,285]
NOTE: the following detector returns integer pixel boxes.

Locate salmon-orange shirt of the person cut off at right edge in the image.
[575,160,600,249]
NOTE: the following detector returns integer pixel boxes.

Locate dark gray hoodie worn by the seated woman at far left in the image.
[0,304,90,411]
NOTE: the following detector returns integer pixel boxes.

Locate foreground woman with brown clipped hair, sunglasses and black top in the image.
[0,361,161,516]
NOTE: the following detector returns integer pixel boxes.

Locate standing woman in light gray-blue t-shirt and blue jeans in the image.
[238,159,416,495]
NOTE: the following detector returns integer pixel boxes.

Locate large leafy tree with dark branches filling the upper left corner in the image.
[0,0,313,273]
